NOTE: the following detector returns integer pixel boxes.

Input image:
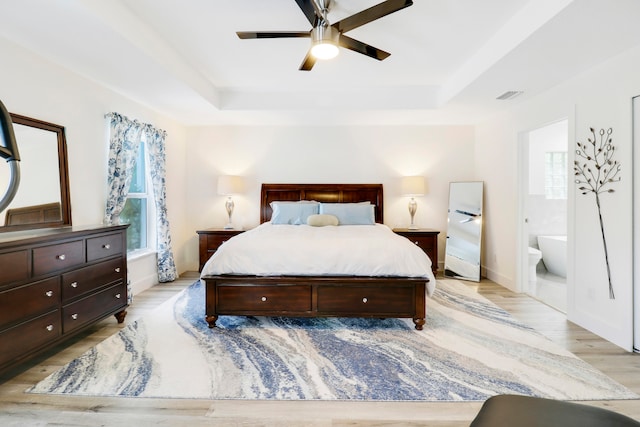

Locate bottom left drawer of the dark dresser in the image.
[0,310,62,366]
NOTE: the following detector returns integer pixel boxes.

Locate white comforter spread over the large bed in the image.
[201,222,436,295]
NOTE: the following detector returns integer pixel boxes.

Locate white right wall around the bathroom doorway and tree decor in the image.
[476,44,640,349]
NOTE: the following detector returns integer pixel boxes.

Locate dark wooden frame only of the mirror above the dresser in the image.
[0,113,71,233]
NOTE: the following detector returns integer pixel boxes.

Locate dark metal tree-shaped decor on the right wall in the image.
[573,128,620,299]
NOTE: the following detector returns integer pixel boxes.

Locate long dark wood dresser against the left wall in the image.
[0,225,127,373]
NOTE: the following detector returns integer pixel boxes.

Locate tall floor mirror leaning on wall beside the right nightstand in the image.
[444,181,483,282]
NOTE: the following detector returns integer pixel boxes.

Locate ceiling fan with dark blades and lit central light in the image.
[236,0,413,71]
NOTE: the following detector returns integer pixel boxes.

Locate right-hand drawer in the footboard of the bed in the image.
[318,286,415,316]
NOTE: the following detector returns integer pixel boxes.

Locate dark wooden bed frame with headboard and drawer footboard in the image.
[202,184,429,330]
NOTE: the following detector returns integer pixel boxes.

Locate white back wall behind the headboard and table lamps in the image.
[186,126,475,269]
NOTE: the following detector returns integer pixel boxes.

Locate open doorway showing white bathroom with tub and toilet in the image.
[520,120,572,313]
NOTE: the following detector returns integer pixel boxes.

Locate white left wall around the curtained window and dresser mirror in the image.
[0,38,191,285]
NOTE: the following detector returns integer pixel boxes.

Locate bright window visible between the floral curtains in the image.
[120,138,155,254]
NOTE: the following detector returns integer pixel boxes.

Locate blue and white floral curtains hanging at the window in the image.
[105,113,177,283]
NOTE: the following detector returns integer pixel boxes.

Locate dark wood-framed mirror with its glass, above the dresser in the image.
[0,114,71,231]
